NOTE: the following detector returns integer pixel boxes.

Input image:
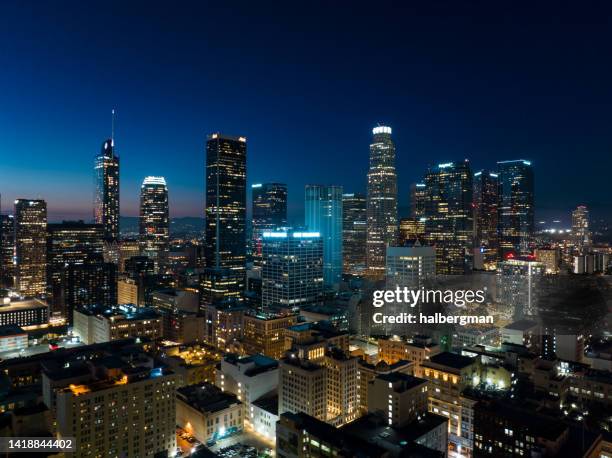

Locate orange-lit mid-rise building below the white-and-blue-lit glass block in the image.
[244,311,298,359]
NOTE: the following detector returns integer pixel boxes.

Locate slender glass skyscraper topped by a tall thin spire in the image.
[94,138,119,240]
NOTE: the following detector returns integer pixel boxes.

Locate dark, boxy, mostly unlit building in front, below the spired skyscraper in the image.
[61,262,117,324]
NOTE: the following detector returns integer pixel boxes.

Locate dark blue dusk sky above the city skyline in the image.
[0,0,612,224]
